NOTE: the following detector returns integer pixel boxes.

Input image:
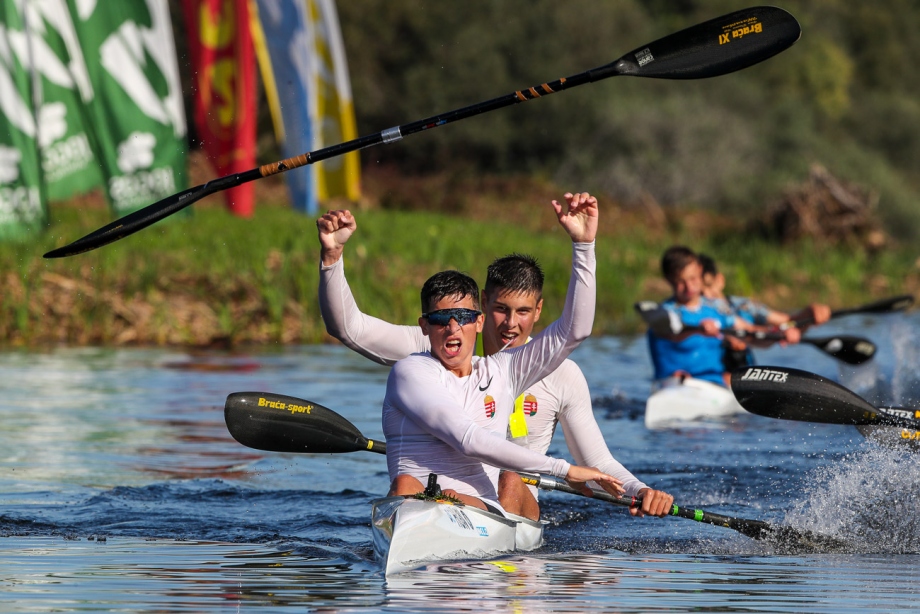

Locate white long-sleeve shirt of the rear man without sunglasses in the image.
[319,241,646,496]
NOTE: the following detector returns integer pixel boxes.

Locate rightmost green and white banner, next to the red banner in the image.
[67,0,187,216]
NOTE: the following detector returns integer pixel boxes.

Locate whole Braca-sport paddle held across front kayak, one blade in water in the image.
[224,392,846,552]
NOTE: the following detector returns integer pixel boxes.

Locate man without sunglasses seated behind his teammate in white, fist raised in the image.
[317,195,673,519]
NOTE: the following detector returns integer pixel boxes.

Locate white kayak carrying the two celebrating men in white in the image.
[371,497,545,575]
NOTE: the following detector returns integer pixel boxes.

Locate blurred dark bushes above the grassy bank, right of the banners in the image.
[332,0,920,240]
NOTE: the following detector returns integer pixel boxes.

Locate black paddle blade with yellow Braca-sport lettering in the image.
[224,392,386,454]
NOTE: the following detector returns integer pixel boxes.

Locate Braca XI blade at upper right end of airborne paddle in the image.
[590,6,802,81]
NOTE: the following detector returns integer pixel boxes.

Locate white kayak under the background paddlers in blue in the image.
[645,377,745,429]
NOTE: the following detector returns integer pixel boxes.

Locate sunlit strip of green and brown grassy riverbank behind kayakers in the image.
[0,204,920,346]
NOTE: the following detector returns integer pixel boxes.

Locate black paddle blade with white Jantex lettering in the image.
[731,367,877,424]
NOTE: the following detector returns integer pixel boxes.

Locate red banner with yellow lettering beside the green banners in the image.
[183,0,257,217]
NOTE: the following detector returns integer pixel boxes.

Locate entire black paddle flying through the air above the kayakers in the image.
[45,6,802,258]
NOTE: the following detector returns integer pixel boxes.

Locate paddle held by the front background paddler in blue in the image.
[635,301,878,365]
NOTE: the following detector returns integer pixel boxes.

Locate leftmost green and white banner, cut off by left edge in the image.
[0,1,47,239]
